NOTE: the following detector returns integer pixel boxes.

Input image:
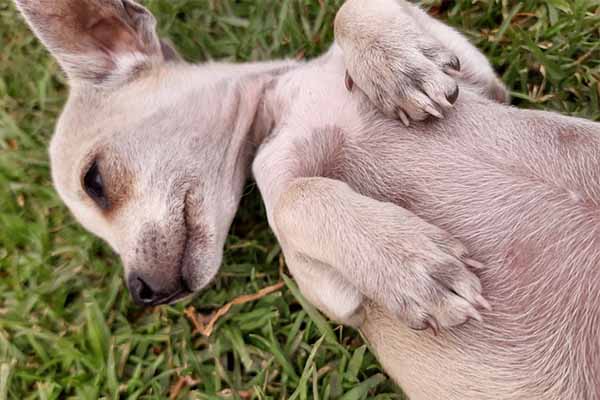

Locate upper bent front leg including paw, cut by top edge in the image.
[335,0,508,123]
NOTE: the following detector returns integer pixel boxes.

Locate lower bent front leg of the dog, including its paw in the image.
[253,132,487,330]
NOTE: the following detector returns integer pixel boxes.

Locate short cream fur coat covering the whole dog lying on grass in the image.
[17,0,600,400]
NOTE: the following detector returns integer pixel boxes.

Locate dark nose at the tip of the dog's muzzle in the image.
[127,273,189,307]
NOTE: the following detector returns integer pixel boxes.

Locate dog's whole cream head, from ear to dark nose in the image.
[16,0,264,305]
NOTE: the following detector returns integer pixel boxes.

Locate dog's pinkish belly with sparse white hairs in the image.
[343,95,600,400]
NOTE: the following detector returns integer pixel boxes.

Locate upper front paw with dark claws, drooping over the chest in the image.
[346,33,461,126]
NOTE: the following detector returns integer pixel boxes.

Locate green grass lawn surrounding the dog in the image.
[0,0,600,400]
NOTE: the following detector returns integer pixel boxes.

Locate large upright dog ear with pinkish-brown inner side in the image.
[15,0,169,85]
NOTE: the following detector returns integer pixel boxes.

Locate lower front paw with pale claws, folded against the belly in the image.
[375,233,491,334]
